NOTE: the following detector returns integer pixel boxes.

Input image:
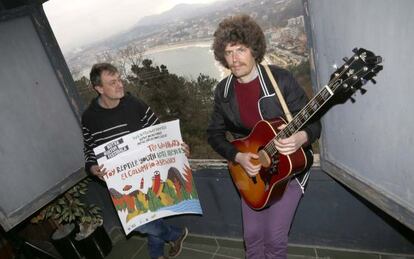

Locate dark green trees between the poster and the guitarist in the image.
[128,59,218,158]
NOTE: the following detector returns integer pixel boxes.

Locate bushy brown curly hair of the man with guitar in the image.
[212,14,266,68]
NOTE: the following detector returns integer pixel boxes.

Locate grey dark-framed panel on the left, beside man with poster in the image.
[0,6,84,231]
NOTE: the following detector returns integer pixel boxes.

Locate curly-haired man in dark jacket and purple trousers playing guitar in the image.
[207,15,321,259]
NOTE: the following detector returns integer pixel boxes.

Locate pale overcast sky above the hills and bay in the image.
[43,0,222,52]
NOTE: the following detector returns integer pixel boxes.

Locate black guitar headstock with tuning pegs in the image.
[328,48,383,98]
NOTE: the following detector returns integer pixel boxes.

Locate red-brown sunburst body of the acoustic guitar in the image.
[228,118,307,210]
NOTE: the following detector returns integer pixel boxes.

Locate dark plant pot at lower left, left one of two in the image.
[50,224,82,259]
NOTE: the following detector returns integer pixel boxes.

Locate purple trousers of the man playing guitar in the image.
[242,179,302,259]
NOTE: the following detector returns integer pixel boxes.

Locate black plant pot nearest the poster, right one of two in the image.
[76,225,112,259]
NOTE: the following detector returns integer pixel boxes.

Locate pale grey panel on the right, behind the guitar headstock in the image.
[304,0,414,232]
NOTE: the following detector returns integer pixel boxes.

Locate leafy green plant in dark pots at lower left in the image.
[31,178,112,259]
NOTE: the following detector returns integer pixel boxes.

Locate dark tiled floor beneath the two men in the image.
[106,231,414,259]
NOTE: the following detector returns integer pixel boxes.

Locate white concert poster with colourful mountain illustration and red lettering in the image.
[94,120,202,234]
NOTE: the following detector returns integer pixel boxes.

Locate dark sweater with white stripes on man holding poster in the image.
[82,93,159,175]
